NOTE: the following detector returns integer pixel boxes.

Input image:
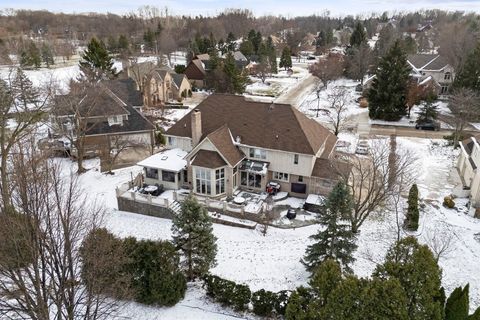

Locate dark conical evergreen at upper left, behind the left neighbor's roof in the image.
[80,38,116,81]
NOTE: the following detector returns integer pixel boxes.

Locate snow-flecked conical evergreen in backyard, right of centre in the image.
[302,182,357,272]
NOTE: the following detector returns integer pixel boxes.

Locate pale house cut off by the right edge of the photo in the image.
[457,137,480,208]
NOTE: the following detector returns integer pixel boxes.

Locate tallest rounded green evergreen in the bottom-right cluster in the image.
[373,237,443,320]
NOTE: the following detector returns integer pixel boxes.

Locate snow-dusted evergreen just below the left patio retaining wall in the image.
[172,196,217,280]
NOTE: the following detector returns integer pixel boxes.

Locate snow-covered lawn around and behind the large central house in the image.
[61,133,480,319]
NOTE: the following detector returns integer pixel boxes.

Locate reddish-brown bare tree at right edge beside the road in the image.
[449,88,480,147]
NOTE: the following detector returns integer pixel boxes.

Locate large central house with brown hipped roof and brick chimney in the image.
[140,94,346,198]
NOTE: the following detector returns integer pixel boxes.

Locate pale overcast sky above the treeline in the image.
[0,0,480,17]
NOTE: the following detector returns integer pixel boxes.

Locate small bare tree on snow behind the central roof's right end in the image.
[327,88,351,136]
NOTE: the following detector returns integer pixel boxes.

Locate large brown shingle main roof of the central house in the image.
[166,94,336,155]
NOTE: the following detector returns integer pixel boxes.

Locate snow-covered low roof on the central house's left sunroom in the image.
[137,149,187,172]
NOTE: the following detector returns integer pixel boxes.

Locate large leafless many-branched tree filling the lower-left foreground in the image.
[0,143,124,320]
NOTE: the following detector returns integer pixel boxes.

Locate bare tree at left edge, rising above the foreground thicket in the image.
[0,69,51,208]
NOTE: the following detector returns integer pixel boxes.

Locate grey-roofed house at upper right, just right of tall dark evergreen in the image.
[407,53,455,96]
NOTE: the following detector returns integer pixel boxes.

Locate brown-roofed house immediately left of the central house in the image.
[53,79,155,159]
